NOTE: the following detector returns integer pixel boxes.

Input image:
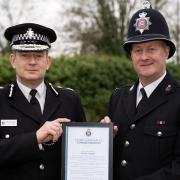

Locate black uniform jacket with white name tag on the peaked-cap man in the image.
[0,83,85,180]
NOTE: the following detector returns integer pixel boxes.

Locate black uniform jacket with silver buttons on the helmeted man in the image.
[109,73,180,180]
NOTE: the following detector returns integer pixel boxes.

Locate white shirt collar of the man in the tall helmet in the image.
[136,71,167,105]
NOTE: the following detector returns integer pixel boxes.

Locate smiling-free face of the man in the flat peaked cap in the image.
[10,51,51,85]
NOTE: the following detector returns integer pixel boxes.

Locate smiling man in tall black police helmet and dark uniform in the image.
[101,1,180,180]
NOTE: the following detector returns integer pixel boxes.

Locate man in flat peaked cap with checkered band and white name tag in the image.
[0,23,85,180]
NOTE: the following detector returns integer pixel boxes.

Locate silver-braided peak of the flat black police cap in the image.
[11,44,49,51]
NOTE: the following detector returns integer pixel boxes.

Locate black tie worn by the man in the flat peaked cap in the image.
[30,89,42,119]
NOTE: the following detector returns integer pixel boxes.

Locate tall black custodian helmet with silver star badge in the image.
[123,1,176,58]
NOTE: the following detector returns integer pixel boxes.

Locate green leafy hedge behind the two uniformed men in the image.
[0,56,180,121]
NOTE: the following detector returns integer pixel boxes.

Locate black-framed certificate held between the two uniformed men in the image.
[61,122,113,180]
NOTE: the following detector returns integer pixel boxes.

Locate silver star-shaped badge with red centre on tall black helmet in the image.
[134,12,152,34]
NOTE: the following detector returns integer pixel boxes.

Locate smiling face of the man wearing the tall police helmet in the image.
[131,40,169,85]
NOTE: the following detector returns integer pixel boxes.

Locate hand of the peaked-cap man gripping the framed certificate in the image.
[36,118,70,144]
